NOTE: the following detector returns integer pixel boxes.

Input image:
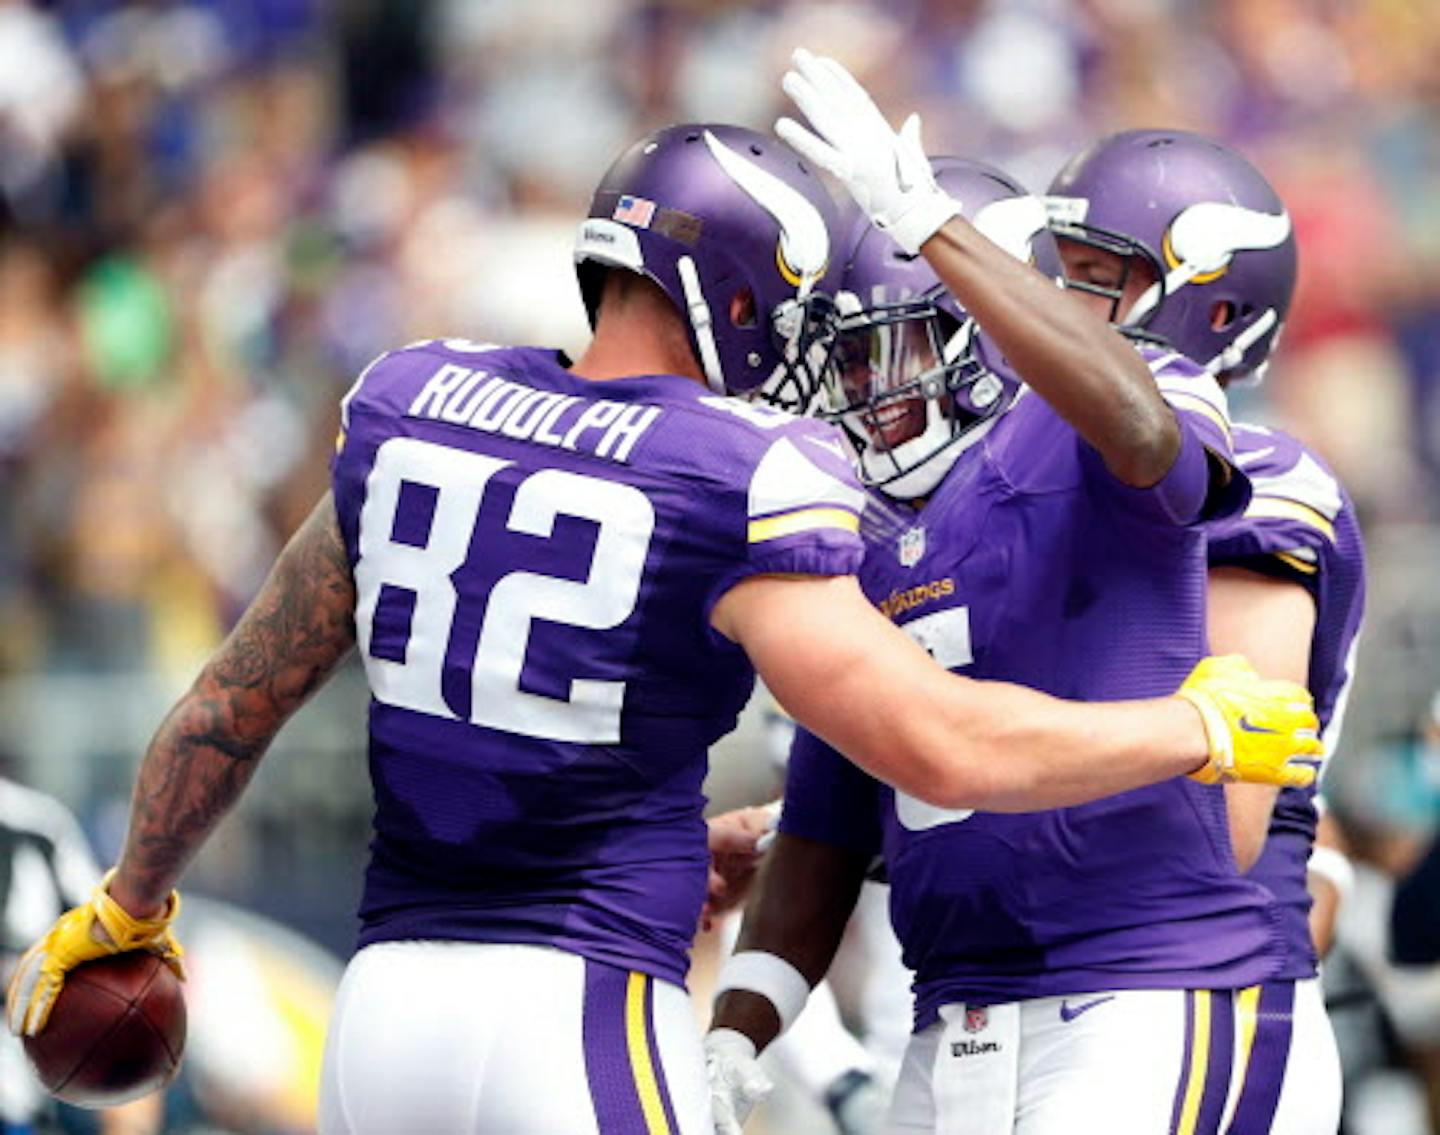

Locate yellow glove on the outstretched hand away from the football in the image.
[1175,654,1325,788]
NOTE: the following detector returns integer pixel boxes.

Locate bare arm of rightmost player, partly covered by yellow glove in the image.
[1207,566,1315,871]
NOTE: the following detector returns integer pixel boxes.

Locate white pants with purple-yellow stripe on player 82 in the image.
[320,942,713,1135]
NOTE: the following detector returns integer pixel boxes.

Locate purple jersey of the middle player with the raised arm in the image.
[782,351,1280,1027]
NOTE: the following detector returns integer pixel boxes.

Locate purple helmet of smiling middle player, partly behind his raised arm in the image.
[824,157,1060,500]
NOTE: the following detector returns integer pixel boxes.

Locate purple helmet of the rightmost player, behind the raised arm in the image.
[1047,130,1295,377]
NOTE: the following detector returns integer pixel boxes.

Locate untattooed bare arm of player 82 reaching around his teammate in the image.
[711,576,1319,812]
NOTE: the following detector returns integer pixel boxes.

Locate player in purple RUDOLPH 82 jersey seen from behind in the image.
[9,125,1318,1135]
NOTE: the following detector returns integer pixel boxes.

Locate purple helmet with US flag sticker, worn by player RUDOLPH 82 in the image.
[575,124,835,408]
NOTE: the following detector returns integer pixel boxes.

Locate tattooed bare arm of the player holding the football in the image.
[109,493,356,918]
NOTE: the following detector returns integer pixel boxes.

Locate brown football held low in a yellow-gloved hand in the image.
[24,951,186,1108]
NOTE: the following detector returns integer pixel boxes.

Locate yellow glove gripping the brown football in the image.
[6,867,184,1037]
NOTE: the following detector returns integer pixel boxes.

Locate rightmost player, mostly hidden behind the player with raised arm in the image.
[1048,130,1365,1132]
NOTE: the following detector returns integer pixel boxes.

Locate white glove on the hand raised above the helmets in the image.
[775,48,960,256]
